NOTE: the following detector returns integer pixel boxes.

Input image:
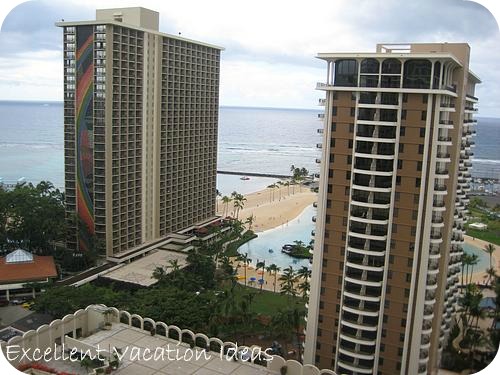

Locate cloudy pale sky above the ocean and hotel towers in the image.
[0,0,500,117]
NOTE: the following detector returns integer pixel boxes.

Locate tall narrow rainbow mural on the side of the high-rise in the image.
[76,26,94,251]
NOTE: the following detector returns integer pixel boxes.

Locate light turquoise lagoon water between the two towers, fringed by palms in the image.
[238,205,316,269]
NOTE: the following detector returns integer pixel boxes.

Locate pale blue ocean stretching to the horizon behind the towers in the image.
[0,101,500,189]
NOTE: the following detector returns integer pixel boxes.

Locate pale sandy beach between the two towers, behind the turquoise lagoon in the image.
[217,185,317,233]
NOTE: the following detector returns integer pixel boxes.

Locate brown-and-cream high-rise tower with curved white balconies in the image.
[304,43,480,374]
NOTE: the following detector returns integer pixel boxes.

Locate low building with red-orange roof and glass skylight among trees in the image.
[0,249,57,300]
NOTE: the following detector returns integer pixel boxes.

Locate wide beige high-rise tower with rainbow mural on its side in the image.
[56,8,221,259]
